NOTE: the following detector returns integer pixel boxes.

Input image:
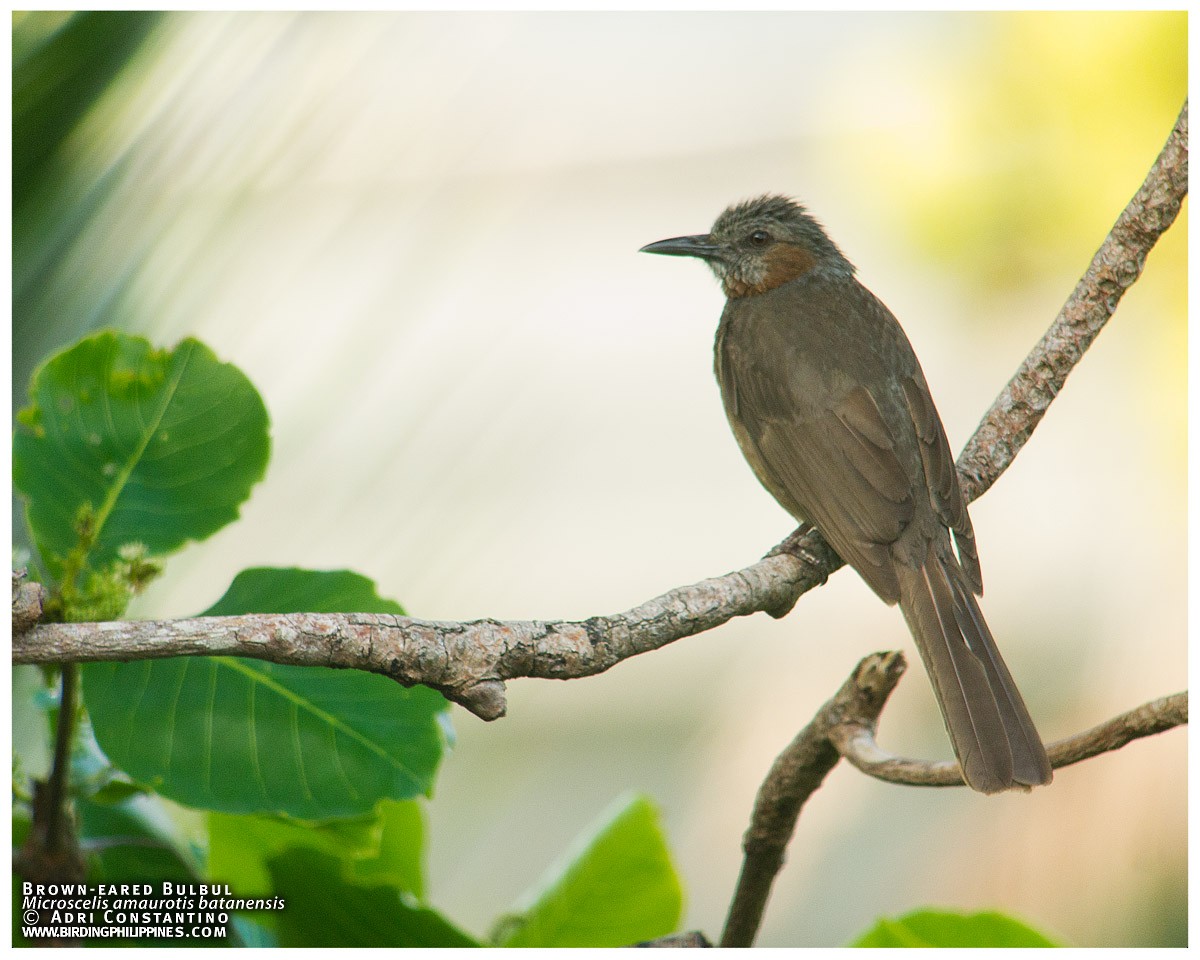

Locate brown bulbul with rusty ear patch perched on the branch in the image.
[642,194,1052,793]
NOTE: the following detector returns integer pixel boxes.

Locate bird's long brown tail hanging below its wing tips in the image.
[896,541,1052,793]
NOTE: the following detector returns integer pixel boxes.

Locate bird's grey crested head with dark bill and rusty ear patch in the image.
[642,196,854,299]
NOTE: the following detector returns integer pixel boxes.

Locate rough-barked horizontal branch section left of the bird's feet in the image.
[12,557,825,720]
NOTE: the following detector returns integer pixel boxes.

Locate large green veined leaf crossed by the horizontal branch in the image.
[83,569,451,820]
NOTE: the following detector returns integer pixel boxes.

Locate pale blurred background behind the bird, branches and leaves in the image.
[13,12,1187,946]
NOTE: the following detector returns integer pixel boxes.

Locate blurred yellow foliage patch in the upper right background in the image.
[875,12,1187,286]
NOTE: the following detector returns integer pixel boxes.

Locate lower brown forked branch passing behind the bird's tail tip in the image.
[720,652,1188,947]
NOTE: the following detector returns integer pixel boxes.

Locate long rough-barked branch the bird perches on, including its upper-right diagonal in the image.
[13,103,1188,720]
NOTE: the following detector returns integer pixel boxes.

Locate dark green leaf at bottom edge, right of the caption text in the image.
[270,850,480,947]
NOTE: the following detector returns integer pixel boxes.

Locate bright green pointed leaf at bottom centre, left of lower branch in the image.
[500,797,683,947]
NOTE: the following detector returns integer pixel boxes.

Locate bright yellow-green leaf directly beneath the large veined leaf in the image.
[209,800,425,899]
